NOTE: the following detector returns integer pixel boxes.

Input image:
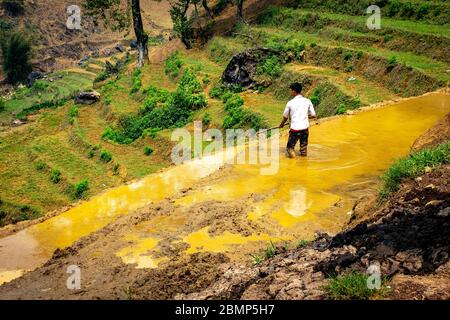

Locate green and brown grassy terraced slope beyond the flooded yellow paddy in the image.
[0,2,450,228]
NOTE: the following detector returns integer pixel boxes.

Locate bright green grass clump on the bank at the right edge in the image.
[380,142,450,198]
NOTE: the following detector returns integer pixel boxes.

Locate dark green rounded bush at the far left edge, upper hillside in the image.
[1,33,32,84]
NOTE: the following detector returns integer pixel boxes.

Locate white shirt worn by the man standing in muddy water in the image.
[283,95,316,131]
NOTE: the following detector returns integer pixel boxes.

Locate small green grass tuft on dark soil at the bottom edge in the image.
[325,272,387,300]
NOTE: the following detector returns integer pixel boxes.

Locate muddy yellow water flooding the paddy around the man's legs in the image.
[0,93,450,283]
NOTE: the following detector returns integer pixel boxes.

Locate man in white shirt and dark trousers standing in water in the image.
[280,82,316,158]
